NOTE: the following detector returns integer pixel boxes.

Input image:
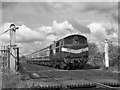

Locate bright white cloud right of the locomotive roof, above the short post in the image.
[87,23,118,51]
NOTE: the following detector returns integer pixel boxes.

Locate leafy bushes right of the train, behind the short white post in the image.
[88,43,120,67]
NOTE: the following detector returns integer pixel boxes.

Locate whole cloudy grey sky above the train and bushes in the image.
[0,0,120,55]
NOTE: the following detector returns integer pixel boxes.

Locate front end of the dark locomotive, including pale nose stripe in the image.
[61,35,88,68]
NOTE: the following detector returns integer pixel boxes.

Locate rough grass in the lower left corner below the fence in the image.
[0,58,20,89]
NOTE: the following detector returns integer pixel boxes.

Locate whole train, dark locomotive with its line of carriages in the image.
[26,34,89,69]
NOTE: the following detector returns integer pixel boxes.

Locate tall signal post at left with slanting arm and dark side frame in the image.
[0,24,19,72]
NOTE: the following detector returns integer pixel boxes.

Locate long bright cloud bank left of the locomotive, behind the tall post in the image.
[0,21,73,43]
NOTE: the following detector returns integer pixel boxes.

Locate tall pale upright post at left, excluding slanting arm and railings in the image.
[9,24,18,72]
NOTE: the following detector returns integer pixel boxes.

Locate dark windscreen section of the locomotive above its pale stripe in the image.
[64,35,87,45]
